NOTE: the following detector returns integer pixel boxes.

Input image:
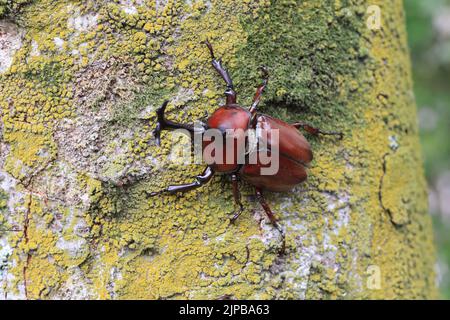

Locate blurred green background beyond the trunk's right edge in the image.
[404,0,450,299]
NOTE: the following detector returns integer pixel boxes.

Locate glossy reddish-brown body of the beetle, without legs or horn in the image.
[203,104,313,192]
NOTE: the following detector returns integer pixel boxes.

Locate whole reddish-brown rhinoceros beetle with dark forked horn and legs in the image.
[150,41,342,240]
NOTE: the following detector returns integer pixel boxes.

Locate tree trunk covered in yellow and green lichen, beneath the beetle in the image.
[0,0,436,299]
